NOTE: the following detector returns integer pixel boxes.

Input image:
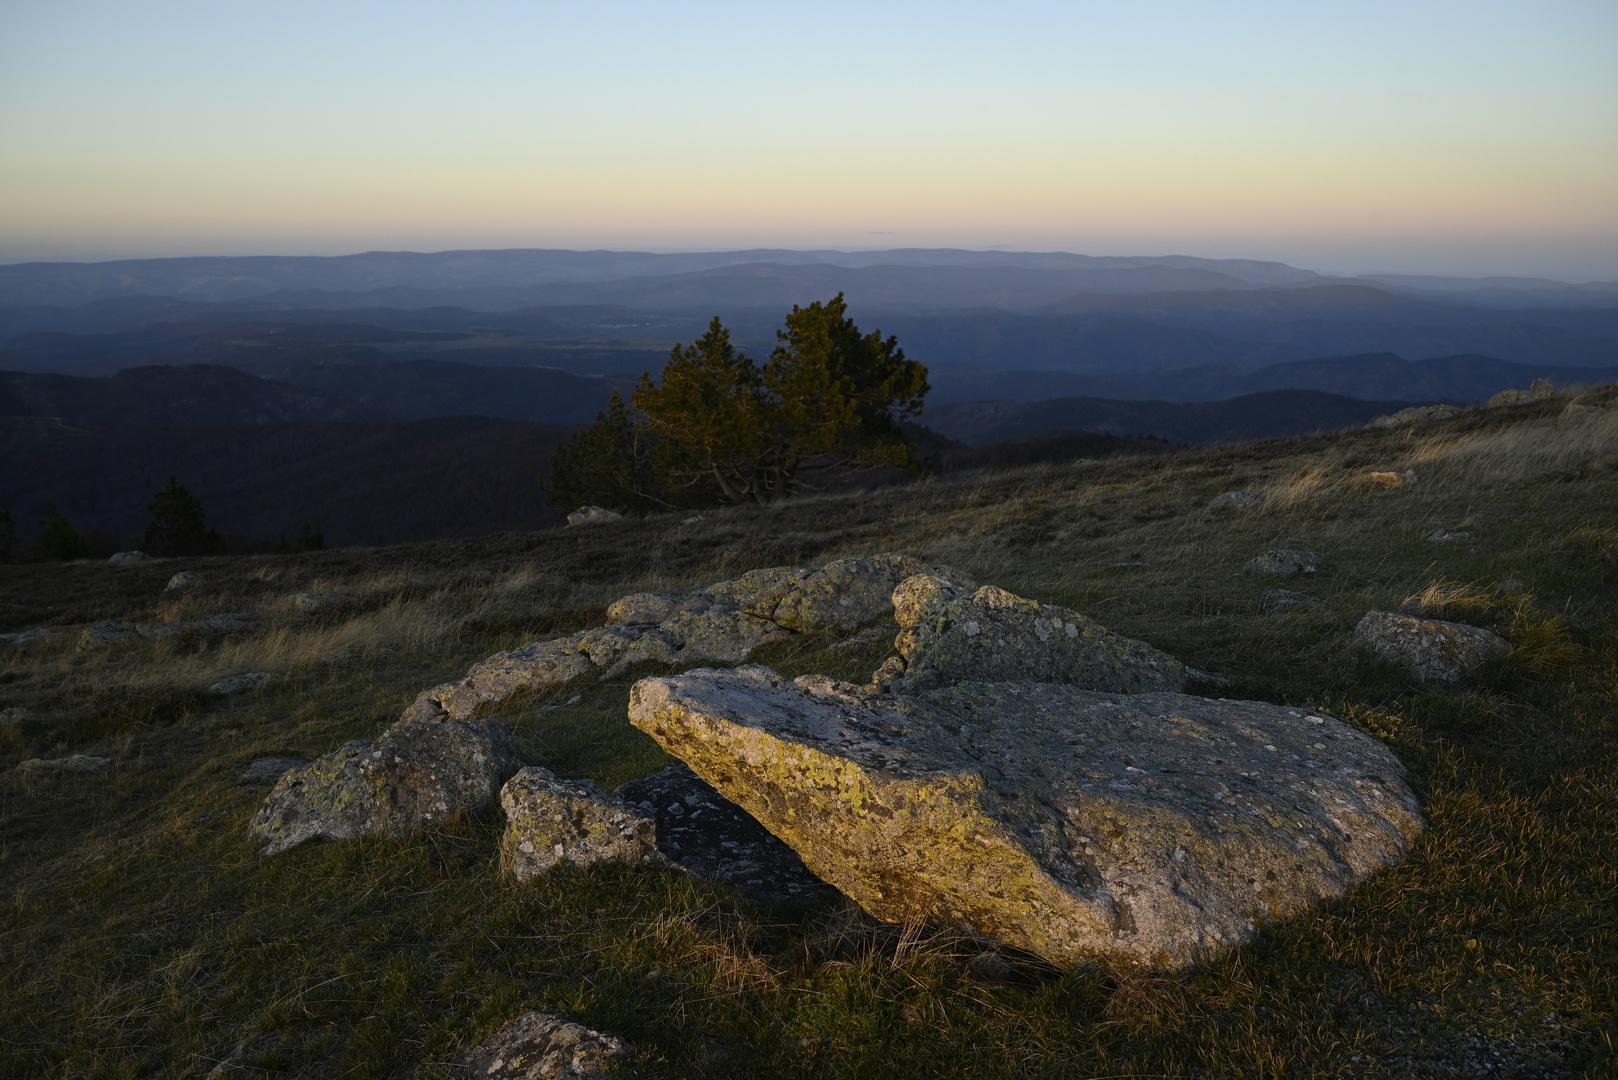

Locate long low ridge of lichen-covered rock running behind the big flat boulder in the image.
[405,554,927,721]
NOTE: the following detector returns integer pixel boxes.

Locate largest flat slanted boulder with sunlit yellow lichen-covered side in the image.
[629,667,1422,968]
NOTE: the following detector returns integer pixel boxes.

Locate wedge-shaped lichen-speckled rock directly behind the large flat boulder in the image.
[885,575,1186,693]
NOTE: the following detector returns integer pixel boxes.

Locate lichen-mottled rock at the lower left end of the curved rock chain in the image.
[249,721,523,855]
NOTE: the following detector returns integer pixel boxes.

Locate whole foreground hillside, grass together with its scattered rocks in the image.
[0,395,1618,1077]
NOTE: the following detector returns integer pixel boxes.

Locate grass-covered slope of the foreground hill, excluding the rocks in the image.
[0,389,1618,1080]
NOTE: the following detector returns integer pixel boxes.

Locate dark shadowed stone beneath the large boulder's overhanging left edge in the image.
[615,764,832,904]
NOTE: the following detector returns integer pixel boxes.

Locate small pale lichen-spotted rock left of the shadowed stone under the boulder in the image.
[500,766,657,881]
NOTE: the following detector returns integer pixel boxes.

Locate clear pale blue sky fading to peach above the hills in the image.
[0,0,1618,280]
